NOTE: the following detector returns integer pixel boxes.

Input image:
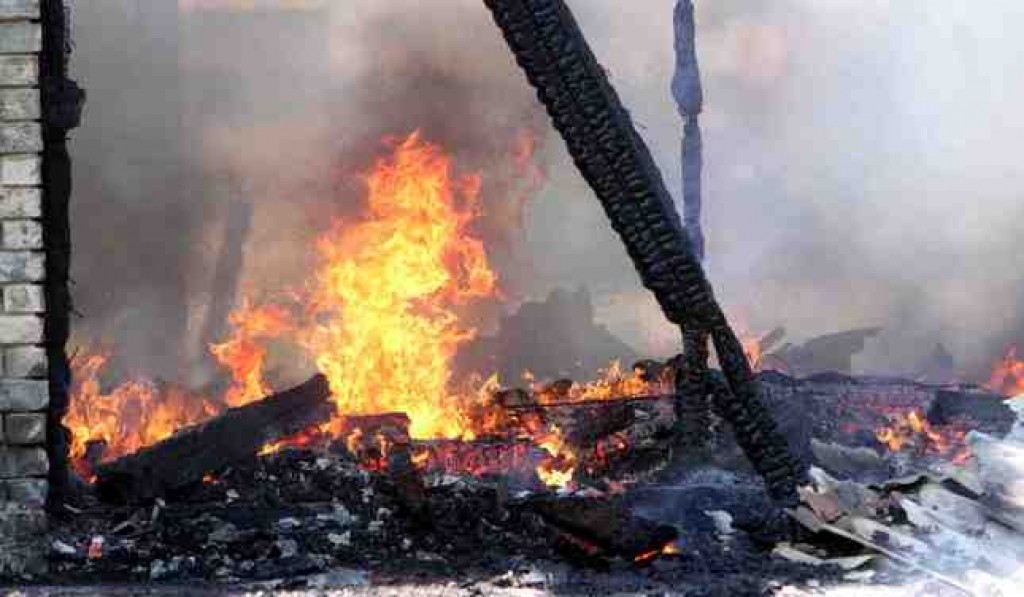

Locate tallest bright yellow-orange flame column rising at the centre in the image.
[303,134,497,438]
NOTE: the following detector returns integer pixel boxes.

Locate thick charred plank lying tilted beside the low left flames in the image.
[96,375,334,503]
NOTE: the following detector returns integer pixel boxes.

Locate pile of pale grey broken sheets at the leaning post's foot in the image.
[775,396,1024,596]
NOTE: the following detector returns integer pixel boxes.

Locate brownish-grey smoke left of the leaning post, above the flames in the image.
[72,0,546,384]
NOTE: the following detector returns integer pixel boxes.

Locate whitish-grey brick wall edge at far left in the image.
[0,0,49,577]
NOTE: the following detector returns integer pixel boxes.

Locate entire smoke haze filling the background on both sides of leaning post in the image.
[72,0,1024,381]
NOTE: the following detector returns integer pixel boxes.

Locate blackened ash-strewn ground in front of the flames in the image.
[9,451,838,596]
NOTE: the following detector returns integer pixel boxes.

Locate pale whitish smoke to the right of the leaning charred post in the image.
[535,0,1024,378]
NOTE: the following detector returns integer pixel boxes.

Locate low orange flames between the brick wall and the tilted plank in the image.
[63,354,217,478]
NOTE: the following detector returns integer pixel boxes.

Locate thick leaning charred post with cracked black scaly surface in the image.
[484,0,805,505]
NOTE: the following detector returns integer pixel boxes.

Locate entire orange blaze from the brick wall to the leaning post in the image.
[68,133,614,486]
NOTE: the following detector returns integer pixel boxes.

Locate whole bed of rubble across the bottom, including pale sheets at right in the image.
[36,366,1024,597]
